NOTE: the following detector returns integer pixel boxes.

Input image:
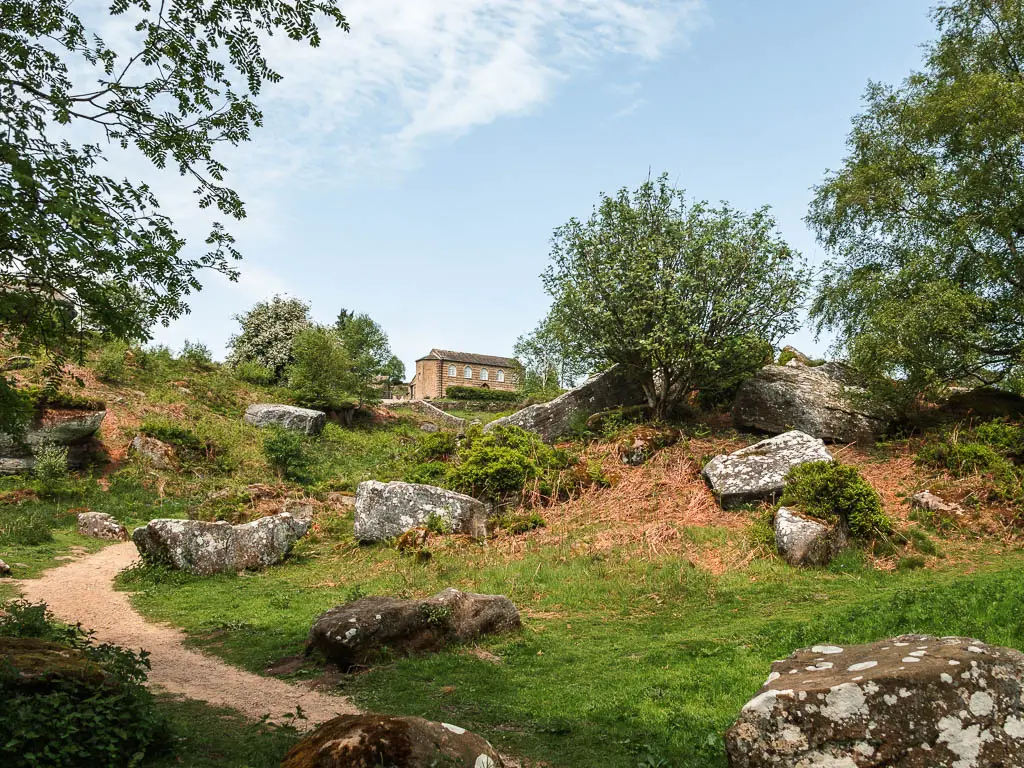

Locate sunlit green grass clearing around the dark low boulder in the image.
[112,505,1024,768]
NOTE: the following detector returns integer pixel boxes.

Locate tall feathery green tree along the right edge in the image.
[808,0,1024,397]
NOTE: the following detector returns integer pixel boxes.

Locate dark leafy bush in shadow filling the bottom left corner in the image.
[0,601,170,768]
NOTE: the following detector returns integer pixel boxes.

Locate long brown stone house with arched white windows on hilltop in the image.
[410,349,519,400]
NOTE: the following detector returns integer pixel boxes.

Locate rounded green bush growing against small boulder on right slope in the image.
[780,461,892,539]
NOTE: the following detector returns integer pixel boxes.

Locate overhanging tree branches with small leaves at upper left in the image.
[0,0,347,428]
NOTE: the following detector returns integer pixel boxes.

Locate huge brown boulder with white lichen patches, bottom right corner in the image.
[725,635,1024,768]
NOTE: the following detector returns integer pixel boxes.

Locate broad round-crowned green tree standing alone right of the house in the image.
[543,176,806,418]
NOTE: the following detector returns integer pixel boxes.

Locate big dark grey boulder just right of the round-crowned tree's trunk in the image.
[732,362,889,442]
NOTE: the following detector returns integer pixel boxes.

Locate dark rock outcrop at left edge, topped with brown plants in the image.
[0,411,106,474]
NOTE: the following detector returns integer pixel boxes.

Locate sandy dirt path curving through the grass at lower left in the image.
[15,542,357,727]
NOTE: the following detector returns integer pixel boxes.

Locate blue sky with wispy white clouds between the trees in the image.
[148,0,934,375]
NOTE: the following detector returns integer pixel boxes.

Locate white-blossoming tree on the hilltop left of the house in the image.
[227,296,309,381]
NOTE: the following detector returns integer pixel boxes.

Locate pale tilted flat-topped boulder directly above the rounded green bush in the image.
[702,430,831,509]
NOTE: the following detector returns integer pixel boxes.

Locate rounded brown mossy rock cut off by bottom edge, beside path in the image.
[281,715,504,768]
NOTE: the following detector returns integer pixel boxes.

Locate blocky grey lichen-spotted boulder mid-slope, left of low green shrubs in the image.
[355,480,488,542]
